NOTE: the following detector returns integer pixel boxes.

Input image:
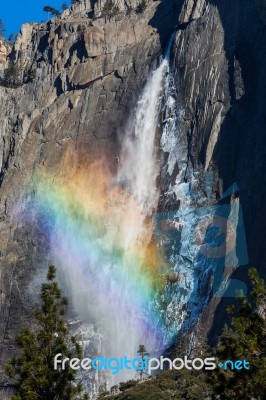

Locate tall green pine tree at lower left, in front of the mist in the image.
[6,266,88,400]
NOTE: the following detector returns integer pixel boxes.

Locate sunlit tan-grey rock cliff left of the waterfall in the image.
[0,0,176,398]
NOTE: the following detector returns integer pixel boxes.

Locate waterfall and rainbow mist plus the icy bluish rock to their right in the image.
[20,27,237,396]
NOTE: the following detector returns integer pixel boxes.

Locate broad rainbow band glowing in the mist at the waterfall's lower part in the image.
[16,161,176,356]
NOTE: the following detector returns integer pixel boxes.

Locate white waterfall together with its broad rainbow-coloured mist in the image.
[21,34,175,393]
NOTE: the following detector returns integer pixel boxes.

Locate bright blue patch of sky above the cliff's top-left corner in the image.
[0,0,70,37]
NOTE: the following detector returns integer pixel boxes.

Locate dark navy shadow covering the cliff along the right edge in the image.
[208,0,266,343]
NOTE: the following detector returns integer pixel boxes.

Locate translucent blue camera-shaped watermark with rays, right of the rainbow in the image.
[154,173,248,303]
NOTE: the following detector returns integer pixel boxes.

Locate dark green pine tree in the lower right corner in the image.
[214,269,266,400]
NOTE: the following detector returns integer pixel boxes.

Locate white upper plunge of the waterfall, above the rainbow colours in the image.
[118,34,175,219]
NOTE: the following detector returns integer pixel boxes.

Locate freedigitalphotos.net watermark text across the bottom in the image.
[54,353,250,375]
